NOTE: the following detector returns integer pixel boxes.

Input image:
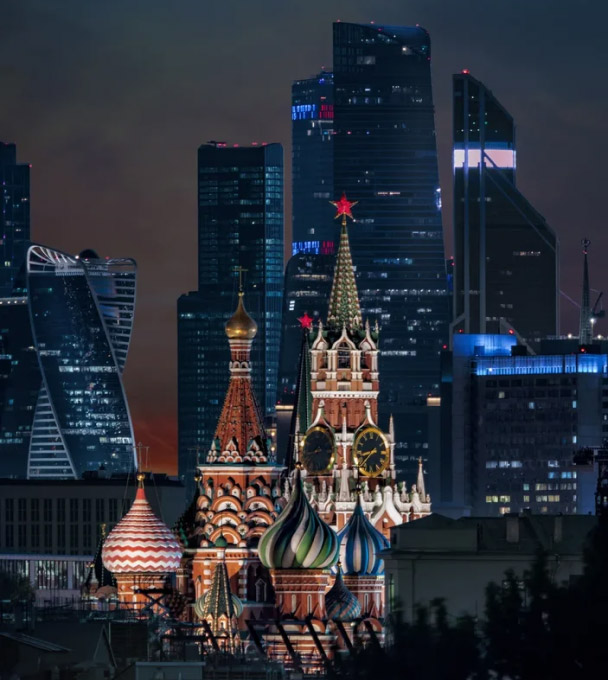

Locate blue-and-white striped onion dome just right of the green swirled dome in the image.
[338,496,390,576]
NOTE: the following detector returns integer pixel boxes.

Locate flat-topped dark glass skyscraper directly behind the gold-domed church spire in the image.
[178,142,283,481]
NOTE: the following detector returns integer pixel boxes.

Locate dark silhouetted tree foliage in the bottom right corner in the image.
[337,519,608,680]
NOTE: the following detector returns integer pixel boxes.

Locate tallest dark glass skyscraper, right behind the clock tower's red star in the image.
[333,22,449,474]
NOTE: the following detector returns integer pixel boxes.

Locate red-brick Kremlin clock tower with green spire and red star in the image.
[292,195,430,536]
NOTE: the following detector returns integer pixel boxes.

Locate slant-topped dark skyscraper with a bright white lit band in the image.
[453,72,559,342]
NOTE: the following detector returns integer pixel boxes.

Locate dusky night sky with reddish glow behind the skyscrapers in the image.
[0,0,608,472]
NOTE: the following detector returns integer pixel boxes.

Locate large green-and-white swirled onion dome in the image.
[258,469,339,569]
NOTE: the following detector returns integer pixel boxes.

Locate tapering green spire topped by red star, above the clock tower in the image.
[328,194,362,329]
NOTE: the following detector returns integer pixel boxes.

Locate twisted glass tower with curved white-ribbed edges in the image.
[26,245,136,478]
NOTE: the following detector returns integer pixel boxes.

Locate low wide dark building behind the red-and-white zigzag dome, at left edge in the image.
[0,474,185,604]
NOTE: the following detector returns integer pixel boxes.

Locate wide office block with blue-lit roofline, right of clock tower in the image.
[435,334,608,516]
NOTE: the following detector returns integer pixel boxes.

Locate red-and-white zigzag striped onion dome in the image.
[101,475,182,574]
